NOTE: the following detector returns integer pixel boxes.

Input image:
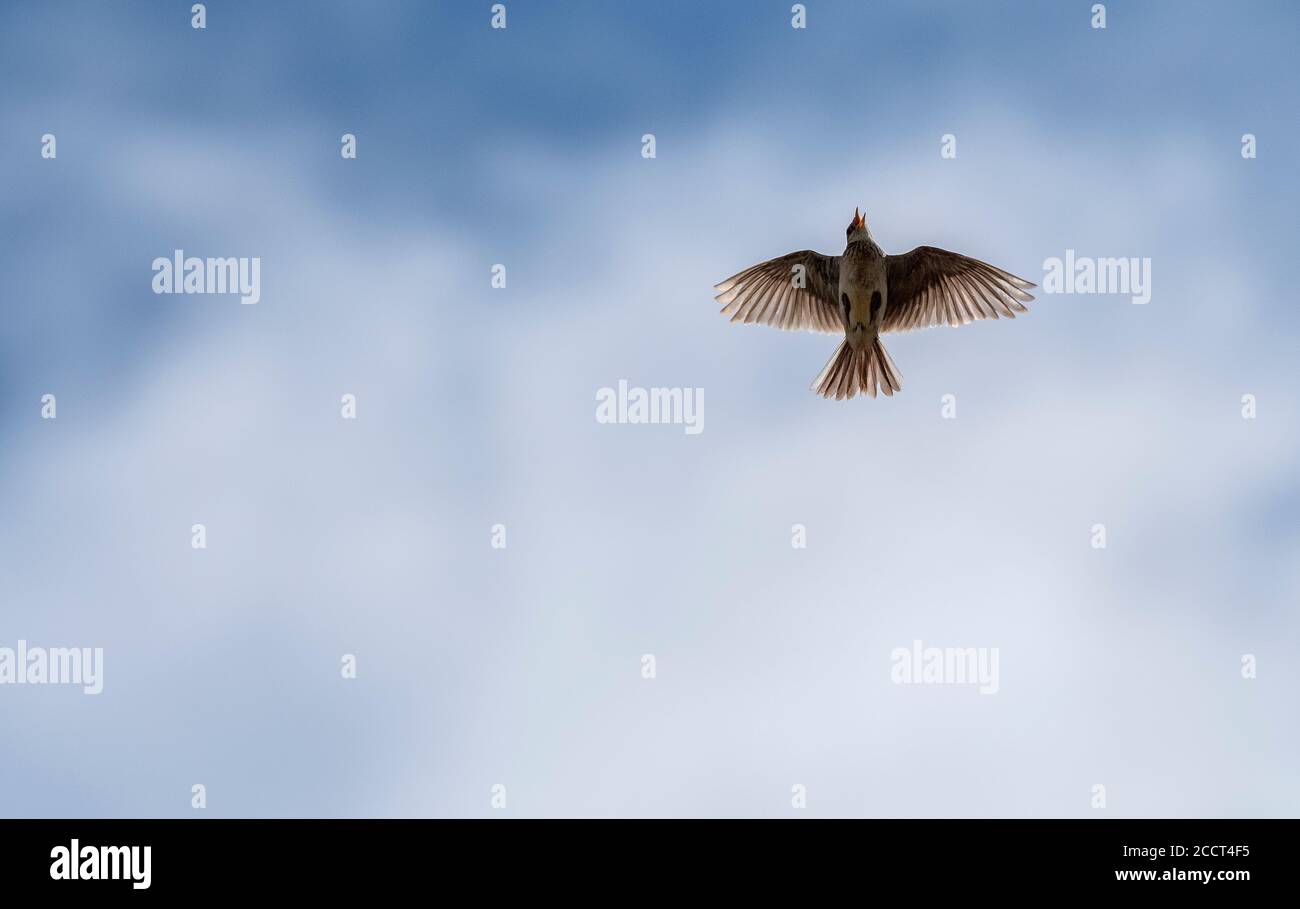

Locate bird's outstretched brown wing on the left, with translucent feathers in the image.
[714,250,844,333]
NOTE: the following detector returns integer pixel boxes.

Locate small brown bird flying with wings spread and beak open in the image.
[714,208,1036,401]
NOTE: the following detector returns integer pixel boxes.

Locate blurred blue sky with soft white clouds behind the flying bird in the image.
[0,0,1300,818]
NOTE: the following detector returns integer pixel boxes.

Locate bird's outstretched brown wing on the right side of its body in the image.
[880,246,1034,332]
